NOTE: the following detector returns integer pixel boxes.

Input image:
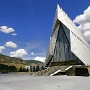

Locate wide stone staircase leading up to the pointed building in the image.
[33,66,68,76]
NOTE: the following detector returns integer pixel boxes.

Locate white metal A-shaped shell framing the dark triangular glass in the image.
[46,4,90,65]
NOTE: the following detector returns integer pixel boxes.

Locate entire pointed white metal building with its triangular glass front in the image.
[45,5,90,67]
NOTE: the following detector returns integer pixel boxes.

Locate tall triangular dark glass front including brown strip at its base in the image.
[51,22,83,65]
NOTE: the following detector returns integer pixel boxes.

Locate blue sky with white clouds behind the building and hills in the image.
[0,0,90,61]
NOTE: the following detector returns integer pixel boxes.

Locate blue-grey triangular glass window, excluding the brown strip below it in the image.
[53,23,84,63]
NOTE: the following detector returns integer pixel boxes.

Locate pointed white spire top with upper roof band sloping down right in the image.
[52,4,90,47]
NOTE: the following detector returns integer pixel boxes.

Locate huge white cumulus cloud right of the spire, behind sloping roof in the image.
[73,6,90,42]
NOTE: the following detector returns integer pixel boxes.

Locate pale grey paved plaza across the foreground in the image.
[0,74,90,90]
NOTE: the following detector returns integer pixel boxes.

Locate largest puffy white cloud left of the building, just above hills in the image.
[10,49,27,57]
